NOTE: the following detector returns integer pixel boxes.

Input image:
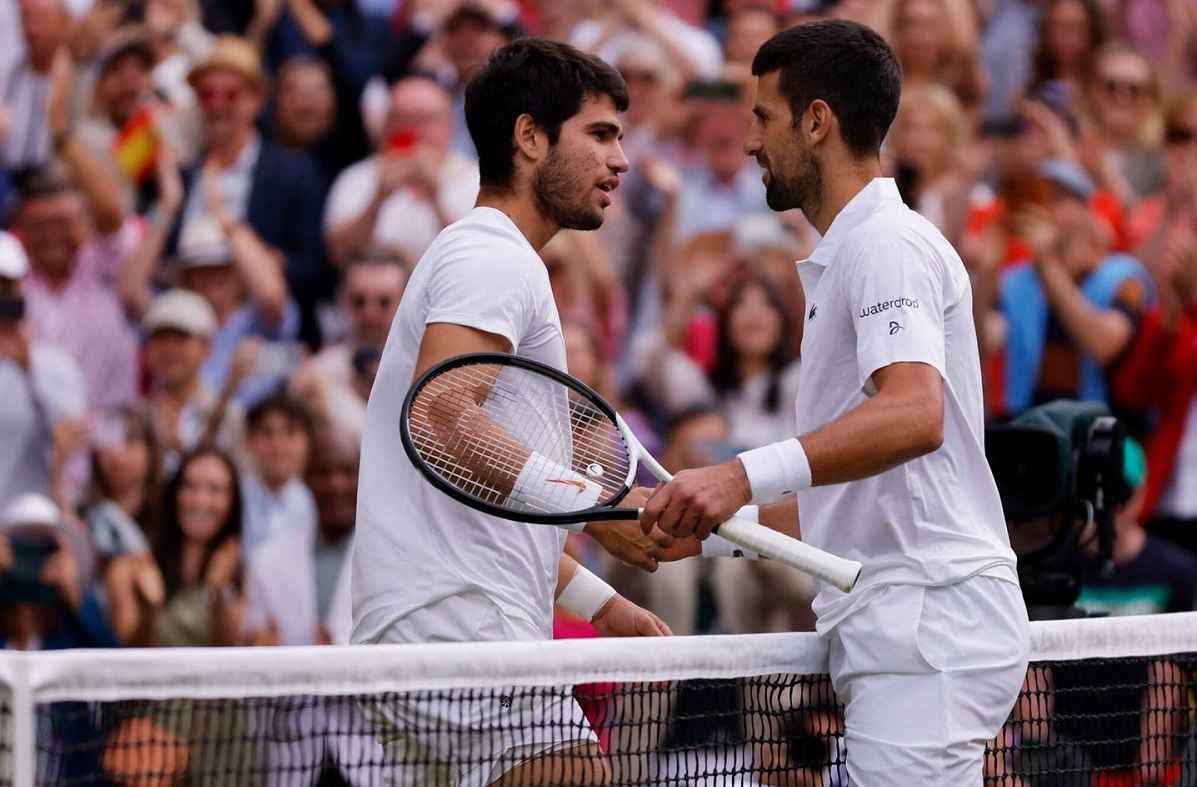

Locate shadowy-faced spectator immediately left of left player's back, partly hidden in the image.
[305,429,361,644]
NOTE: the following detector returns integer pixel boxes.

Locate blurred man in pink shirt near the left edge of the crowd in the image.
[13,165,140,407]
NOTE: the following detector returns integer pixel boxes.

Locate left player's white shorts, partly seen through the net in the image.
[363,597,599,787]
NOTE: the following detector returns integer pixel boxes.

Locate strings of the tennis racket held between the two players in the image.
[408,363,631,514]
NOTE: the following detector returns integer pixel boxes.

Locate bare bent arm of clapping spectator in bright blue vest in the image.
[1016,210,1137,367]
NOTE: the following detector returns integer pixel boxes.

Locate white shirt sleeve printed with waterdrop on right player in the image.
[847,233,947,395]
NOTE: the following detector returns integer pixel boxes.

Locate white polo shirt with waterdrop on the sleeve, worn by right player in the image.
[796,178,1017,632]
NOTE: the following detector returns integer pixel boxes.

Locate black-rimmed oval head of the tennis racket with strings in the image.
[400,352,638,525]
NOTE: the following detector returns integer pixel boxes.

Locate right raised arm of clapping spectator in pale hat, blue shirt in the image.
[201,162,288,327]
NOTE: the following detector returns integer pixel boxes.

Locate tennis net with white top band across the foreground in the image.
[0,613,1197,787]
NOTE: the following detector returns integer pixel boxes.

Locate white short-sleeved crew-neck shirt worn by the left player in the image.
[352,207,566,643]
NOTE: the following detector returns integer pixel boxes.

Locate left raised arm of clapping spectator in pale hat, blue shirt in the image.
[116,145,183,322]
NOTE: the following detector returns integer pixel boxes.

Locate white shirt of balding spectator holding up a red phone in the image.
[324,151,478,259]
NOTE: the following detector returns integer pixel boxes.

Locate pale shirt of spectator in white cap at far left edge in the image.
[0,344,87,509]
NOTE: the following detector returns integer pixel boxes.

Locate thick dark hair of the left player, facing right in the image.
[466,38,627,189]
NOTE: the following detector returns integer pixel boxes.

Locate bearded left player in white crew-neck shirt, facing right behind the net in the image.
[352,38,669,787]
